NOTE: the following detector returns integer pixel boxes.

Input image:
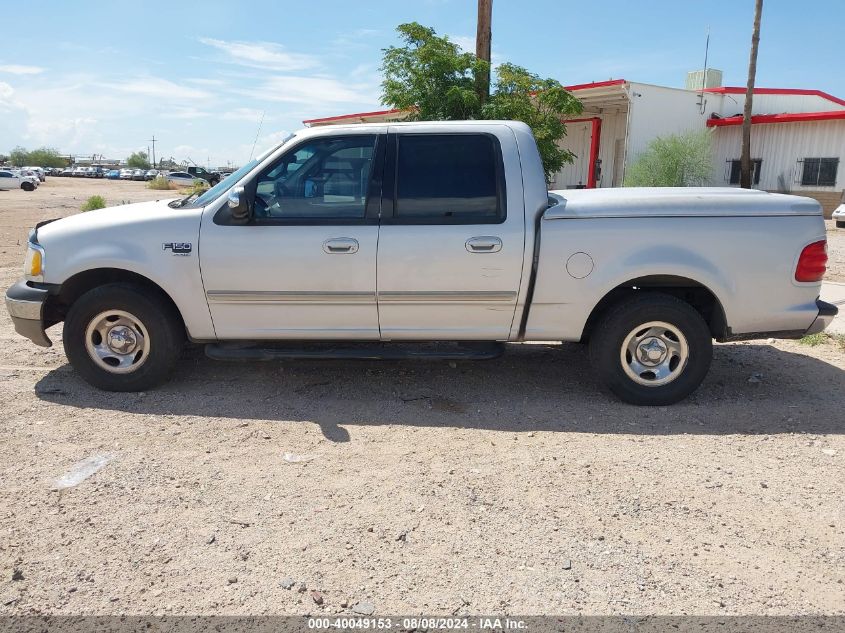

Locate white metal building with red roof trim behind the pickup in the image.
[304,75,845,215]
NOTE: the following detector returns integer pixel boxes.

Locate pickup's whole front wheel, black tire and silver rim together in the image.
[63,283,185,391]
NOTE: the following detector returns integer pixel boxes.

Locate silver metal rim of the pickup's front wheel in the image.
[85,310,150,374]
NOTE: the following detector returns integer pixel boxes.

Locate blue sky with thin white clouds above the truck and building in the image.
[0,0,845,166]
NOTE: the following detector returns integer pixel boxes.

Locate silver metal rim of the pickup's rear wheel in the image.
[619,321,689,387]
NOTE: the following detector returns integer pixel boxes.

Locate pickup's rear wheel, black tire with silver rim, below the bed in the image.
[590,293,713,406]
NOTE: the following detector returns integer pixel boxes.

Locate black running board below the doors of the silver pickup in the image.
[205,341,505,362]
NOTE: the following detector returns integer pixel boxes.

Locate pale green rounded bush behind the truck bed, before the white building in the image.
[625,130,713,187]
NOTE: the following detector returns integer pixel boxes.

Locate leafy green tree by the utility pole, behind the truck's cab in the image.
[382,22,581,180]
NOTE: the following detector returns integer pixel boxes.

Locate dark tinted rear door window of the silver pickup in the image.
[396,134,505,224]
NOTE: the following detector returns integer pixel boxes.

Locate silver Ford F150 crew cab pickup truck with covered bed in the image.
[6,121,836,405]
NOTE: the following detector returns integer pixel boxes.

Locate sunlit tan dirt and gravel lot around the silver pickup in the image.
[0,178,845,615]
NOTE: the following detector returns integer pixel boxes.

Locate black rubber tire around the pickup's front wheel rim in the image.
[63,283,185,391]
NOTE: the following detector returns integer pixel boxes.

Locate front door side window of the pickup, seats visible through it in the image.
[255,134,376,220]
